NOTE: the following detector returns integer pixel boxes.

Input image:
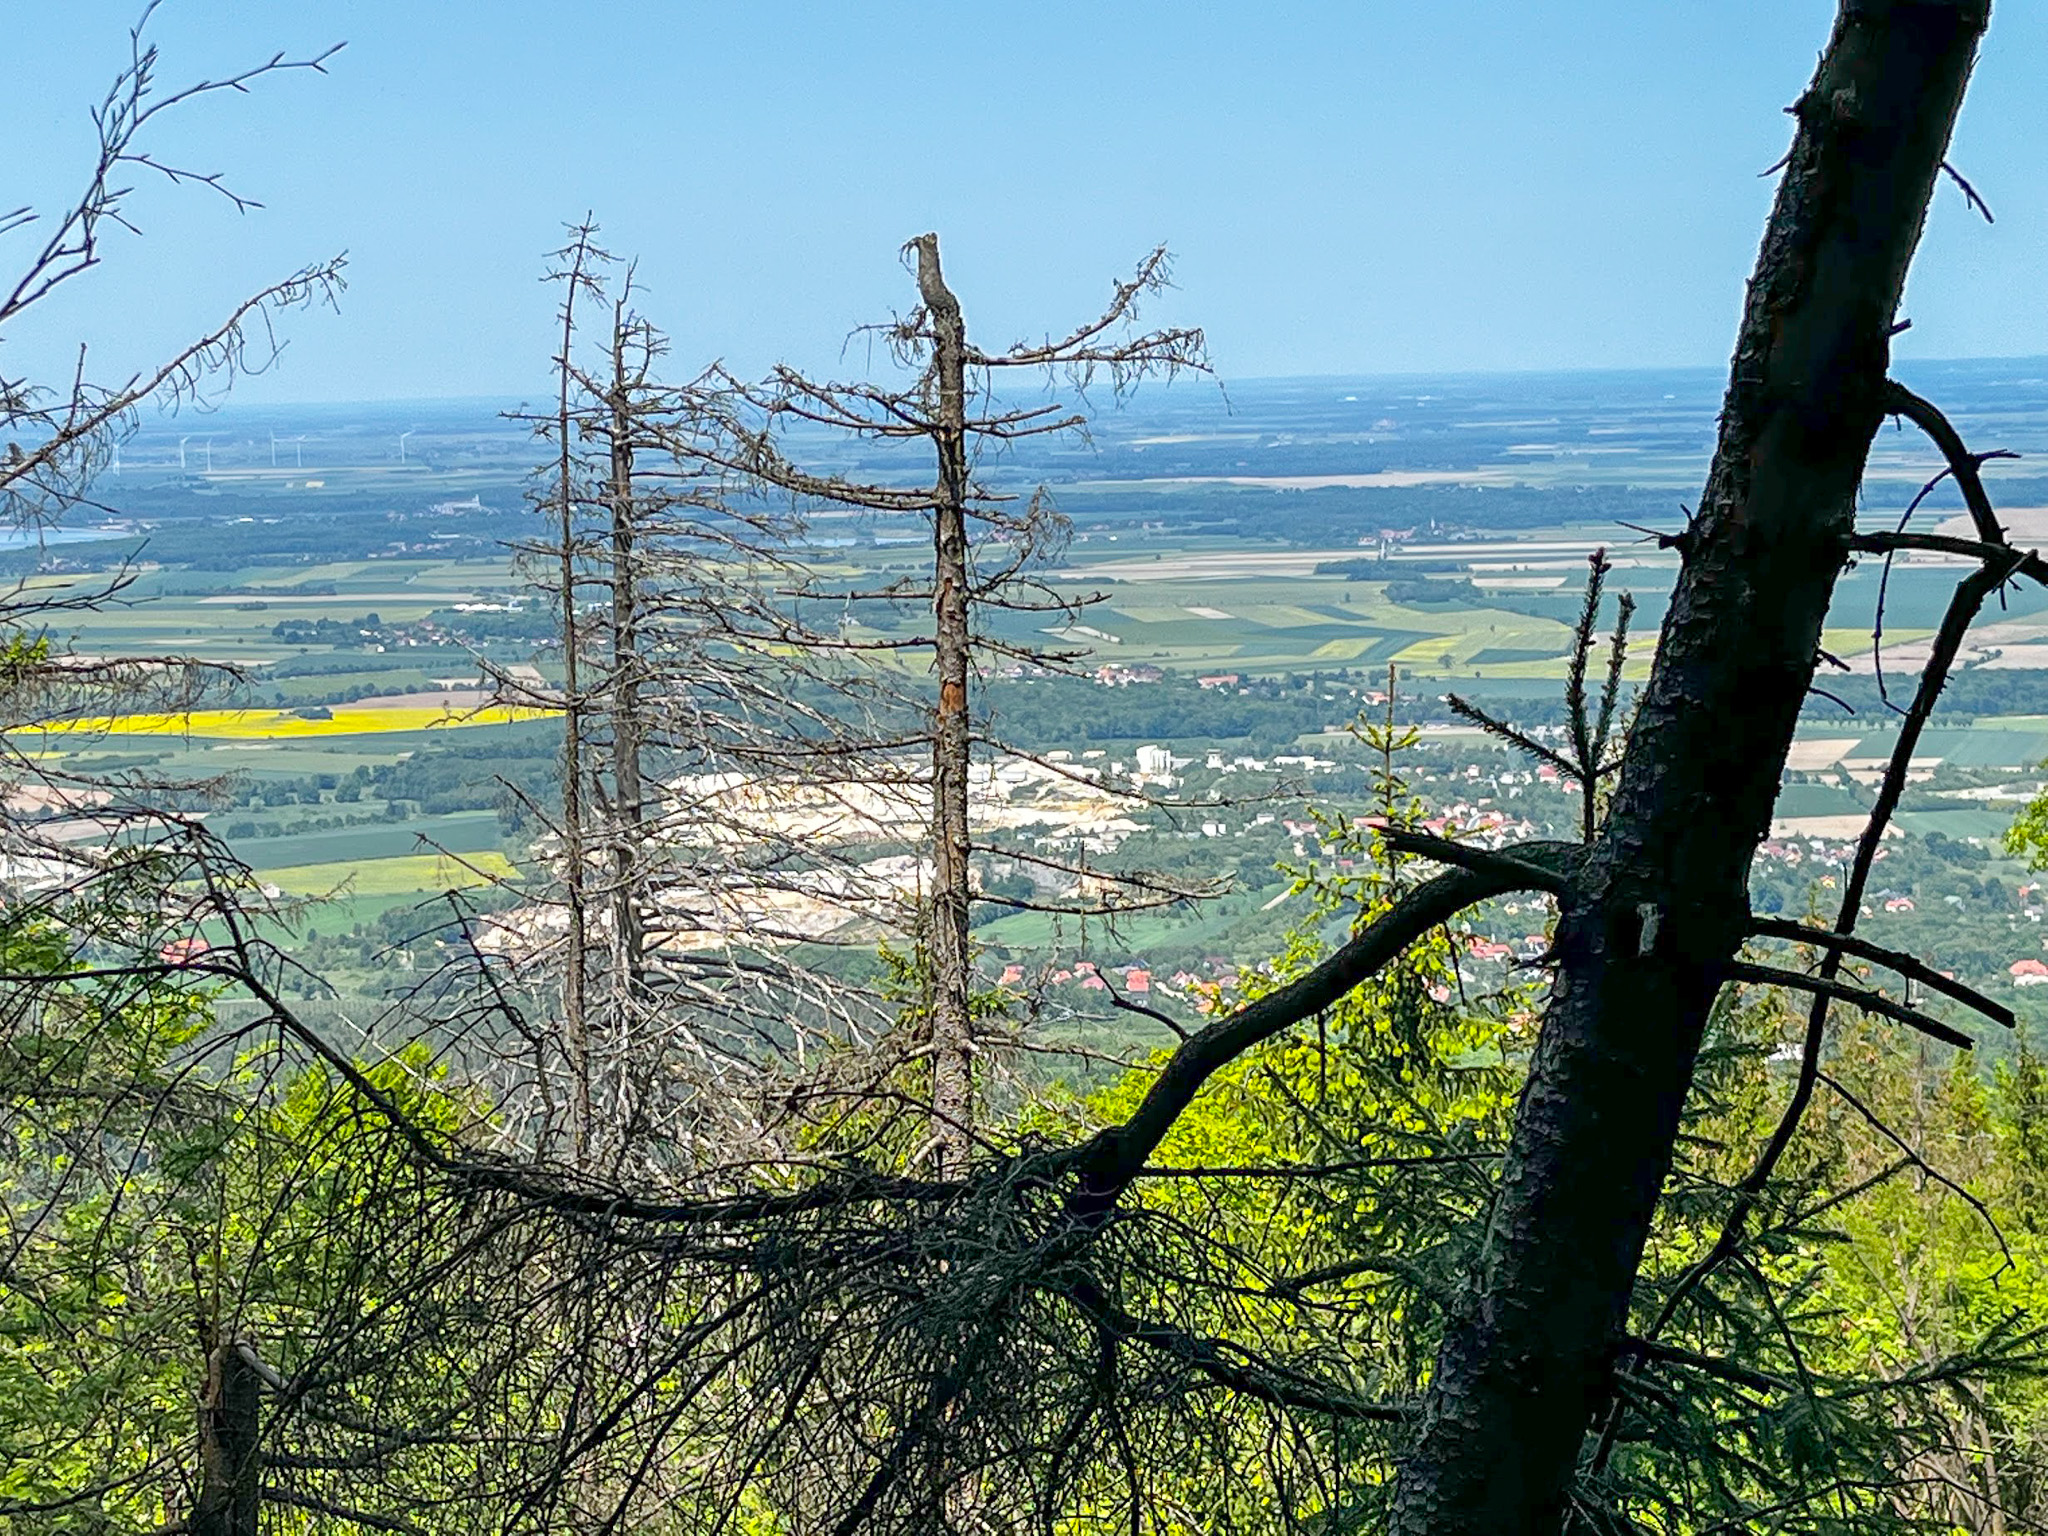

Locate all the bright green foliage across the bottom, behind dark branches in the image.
[0,721,2048,1536]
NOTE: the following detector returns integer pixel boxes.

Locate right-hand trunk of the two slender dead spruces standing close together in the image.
[608,303,647,1008]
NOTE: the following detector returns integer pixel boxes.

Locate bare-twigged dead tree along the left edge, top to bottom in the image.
[0,24,483,1536]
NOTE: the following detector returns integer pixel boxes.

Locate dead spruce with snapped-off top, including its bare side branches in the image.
[696,233,1208,1174]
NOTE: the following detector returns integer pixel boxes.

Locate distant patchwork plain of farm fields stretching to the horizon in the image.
[12,365,2048,1011]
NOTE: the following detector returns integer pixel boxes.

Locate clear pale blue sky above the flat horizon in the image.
[0,0,2048,401]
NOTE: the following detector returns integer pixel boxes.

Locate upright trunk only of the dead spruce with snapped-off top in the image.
[911,236,975,1174]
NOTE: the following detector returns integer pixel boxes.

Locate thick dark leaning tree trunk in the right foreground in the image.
[1391,0,1989,1536]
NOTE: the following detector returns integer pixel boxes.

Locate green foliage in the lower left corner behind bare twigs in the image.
[0,926,479,1536]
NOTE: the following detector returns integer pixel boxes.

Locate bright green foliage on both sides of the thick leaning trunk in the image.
[1032,725,2048,1532]
